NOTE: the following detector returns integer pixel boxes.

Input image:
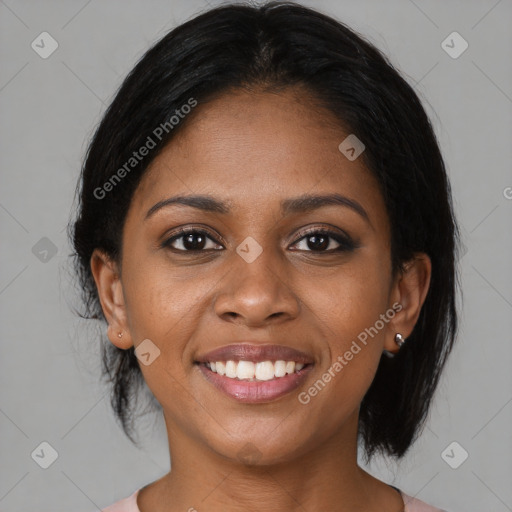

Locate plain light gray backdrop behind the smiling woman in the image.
[0,0,512,512]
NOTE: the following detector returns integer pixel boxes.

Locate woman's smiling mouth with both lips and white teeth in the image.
[194,344,314,403]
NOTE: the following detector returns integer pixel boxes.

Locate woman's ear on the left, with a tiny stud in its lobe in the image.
[90,249,133,349]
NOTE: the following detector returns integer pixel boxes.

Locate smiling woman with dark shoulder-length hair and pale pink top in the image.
[70,3,458,512]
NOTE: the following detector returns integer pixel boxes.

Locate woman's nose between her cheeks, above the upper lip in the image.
[214,250,300,327]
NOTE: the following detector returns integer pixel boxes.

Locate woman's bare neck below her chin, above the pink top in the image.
[138,413,402,512]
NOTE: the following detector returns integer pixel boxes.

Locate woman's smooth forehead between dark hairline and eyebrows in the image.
[132,91,385,227]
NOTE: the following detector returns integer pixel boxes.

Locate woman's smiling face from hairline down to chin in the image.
[94,91,422,464]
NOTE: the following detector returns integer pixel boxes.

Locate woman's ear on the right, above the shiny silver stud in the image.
[384,253,432,353]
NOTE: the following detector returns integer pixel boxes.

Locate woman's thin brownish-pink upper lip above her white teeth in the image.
[196,343,313,364]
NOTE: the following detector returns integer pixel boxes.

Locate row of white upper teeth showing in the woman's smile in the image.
[206,360,305,381]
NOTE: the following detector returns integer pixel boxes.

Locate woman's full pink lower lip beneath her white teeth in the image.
[197,364,313,404]
